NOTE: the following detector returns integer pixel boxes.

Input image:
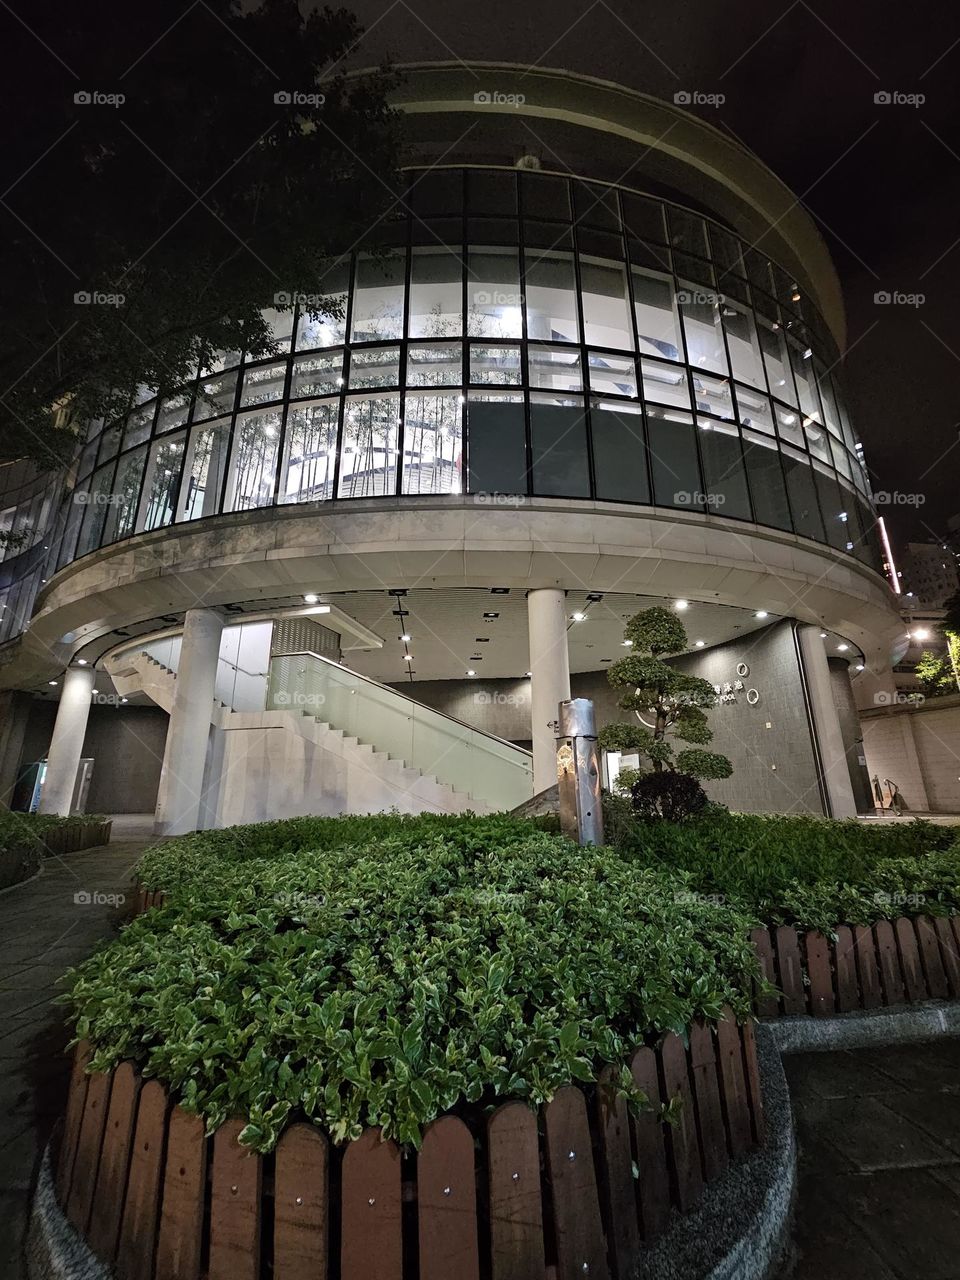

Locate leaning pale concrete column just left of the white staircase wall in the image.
[155,609,223,836]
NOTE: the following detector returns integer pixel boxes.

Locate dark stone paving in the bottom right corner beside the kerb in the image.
[783,1039,960,1280]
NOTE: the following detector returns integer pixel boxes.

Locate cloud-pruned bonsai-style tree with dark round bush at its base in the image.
[599,608,733,818]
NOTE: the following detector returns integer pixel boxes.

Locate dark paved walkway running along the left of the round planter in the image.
[0,815,152,1280]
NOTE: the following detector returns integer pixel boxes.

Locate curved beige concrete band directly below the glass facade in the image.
[0,494,902,689]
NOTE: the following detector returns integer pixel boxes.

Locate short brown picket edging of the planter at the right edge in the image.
[751,915,960,1018]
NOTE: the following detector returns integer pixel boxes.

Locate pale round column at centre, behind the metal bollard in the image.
[526,588,570,795]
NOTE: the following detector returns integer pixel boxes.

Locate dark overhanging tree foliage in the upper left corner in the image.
[0,0,398,467]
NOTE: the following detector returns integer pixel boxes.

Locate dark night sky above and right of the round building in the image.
[351,0,960,558]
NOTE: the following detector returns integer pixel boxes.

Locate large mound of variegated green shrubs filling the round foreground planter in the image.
[65,818,758,1151]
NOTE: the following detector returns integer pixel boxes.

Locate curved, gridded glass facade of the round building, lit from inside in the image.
[51,168,882,571]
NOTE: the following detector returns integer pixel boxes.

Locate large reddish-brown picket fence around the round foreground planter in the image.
[56,1011,763,1280]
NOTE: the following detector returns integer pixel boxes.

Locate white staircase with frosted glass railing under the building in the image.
[105,648,532,826]
